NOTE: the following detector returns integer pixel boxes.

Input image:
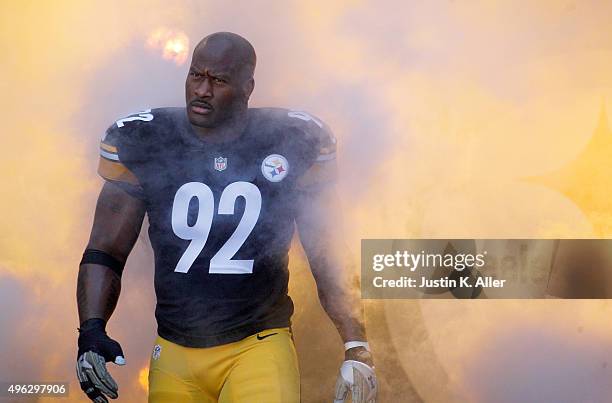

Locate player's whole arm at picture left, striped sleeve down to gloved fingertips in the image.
[76,113,145,403]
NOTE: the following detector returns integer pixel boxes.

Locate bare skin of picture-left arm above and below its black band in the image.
[77,182,145,323]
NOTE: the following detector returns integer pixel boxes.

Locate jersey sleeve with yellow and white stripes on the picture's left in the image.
[98,119,143,199]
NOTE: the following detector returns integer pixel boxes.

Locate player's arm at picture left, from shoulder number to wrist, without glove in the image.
[77,110,153,325]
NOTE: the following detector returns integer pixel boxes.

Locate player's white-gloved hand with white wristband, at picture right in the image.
[334,347,378,403]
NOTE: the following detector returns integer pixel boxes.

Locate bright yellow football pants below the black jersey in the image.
[149,328,300,403]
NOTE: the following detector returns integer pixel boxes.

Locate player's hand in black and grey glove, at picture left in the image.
[76,318,125,403]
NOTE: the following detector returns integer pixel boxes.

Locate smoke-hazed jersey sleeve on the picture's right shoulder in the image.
[289,112,338,190]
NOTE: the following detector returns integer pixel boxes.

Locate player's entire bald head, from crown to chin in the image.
[185,32,256,128]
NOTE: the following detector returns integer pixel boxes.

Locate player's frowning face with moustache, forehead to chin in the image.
[185,50,250,128]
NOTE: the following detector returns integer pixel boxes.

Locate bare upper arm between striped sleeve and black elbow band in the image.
[87,182,145,261]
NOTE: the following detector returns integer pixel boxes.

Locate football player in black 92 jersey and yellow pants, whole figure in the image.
[77,32,377,403]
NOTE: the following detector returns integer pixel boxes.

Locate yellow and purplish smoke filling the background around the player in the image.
[0,0,612,402]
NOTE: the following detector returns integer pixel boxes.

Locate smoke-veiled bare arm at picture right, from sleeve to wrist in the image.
[296,186,366,362]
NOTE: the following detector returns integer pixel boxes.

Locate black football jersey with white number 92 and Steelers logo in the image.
[99,108,335,347]
